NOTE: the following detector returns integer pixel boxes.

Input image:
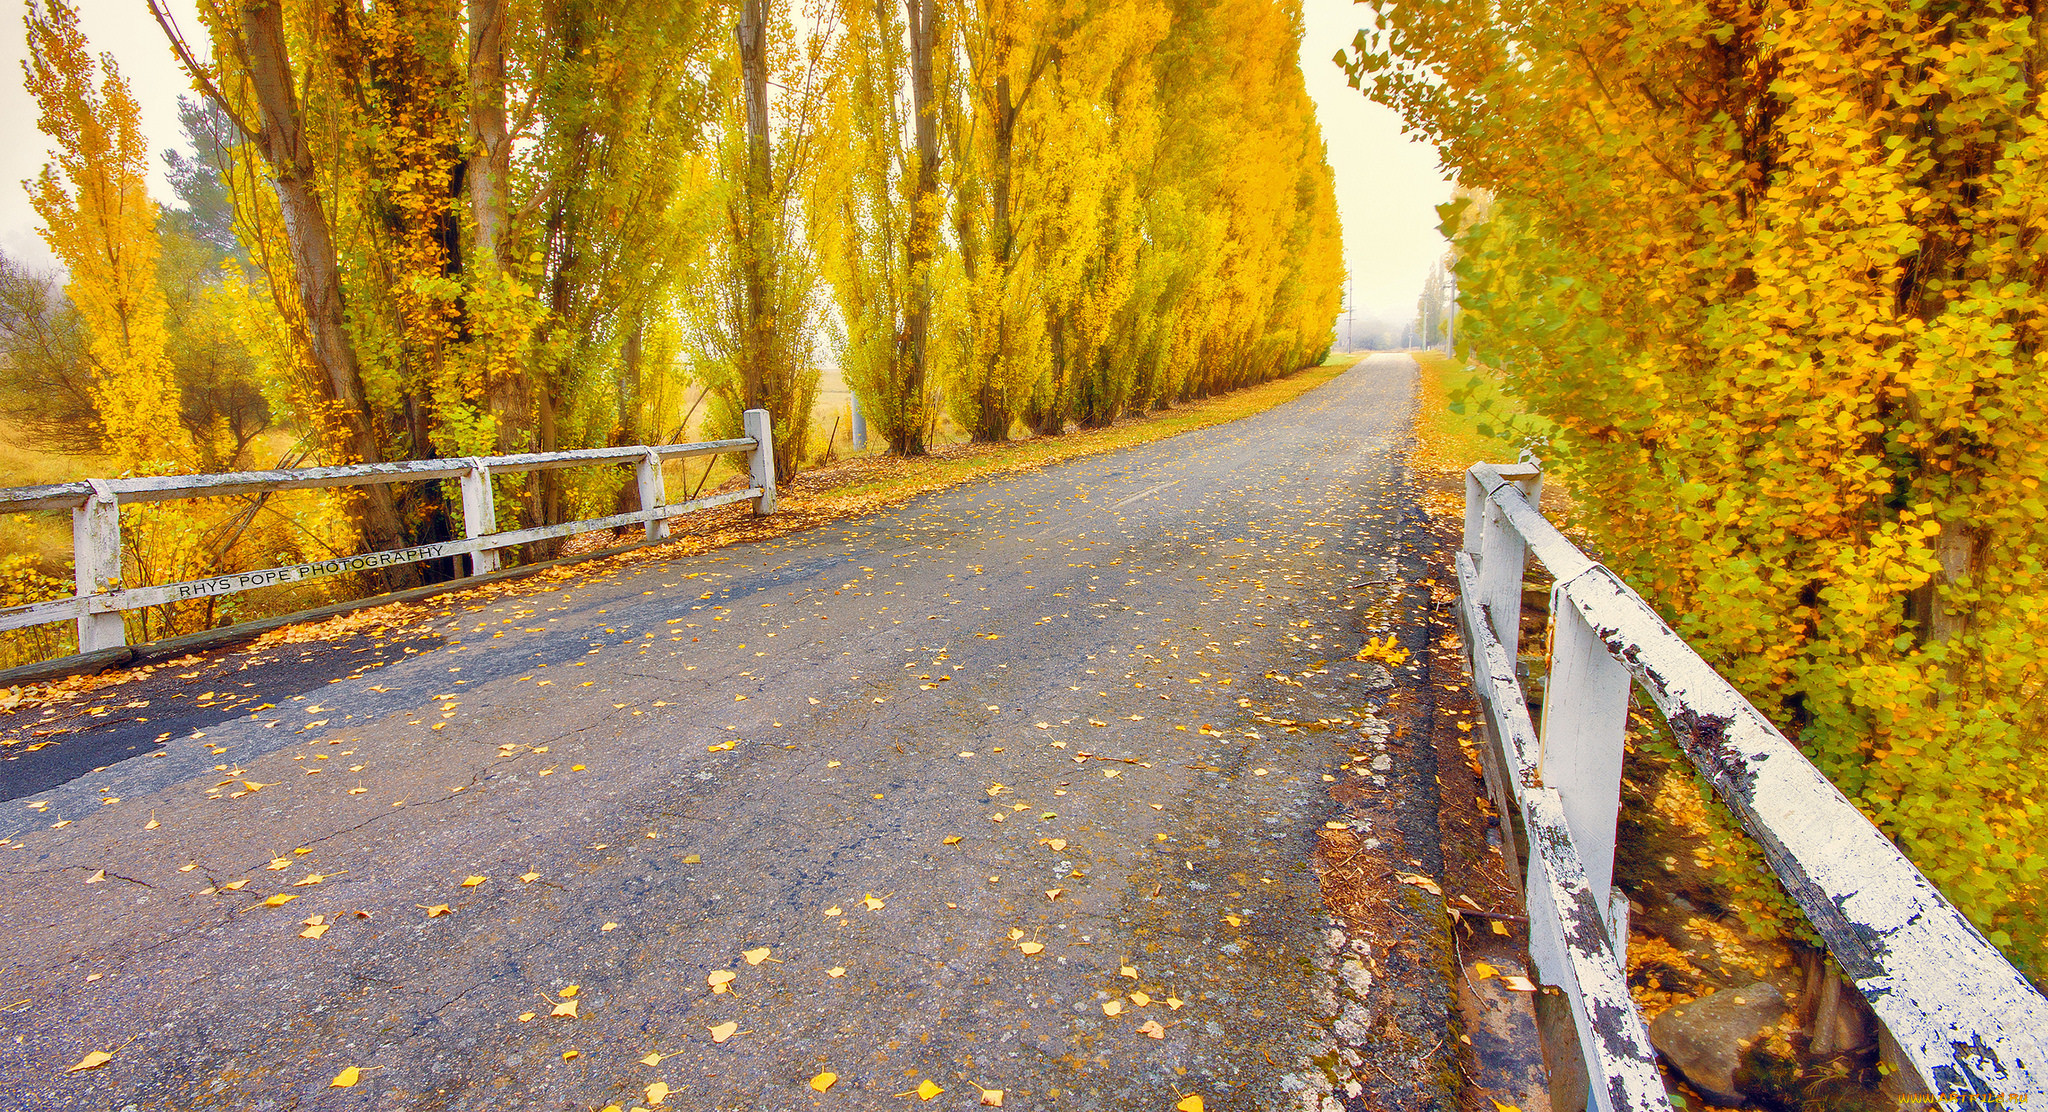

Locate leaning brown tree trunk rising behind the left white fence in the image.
[242,0,418,586]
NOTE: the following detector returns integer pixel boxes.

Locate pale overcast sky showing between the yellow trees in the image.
[0,0,1450,324]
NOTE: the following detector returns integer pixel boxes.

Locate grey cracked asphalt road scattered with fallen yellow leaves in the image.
[0,356,1442,1110]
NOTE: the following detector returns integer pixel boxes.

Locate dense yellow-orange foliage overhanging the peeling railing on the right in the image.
[1339,0,2048,975]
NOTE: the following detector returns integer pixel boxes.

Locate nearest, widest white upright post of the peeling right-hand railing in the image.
[1536,586,1630,946]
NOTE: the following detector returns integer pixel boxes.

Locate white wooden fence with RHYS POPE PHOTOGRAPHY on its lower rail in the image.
[0,410,774,653]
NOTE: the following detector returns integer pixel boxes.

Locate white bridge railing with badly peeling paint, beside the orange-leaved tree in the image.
[1456,463,2048,1112]
